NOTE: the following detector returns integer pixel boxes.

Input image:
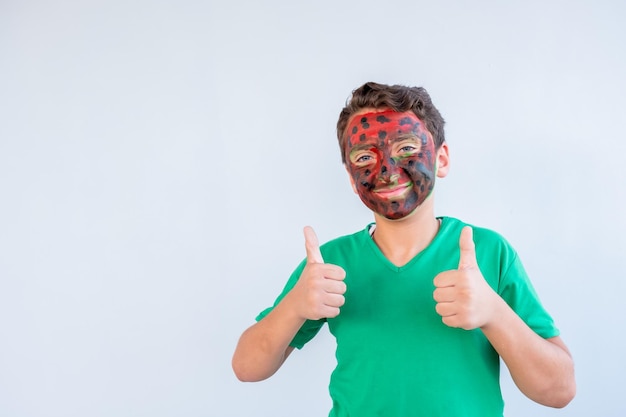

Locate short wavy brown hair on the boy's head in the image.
[337,82,445,163]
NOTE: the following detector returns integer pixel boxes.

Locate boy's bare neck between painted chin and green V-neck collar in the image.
[373,196,439,266]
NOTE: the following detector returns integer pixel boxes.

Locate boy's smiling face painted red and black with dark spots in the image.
[345,110,437,220]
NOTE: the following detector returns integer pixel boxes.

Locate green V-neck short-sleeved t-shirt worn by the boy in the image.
[257,217,559,417]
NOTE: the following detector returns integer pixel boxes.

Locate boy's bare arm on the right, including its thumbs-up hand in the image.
[433,227,576,407]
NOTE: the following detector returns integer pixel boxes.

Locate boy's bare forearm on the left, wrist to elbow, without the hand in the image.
[232,297,304,382]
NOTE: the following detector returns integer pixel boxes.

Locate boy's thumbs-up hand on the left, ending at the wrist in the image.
[289,226,346,320]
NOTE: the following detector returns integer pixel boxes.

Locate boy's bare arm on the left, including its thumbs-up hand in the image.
[232,227,346,382]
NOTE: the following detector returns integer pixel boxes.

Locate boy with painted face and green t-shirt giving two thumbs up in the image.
[233,83,576,417]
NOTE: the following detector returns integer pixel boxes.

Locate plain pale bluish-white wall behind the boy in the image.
[0,0,626,417]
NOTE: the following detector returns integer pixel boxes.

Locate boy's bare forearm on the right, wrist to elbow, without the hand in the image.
[481,299,576,408]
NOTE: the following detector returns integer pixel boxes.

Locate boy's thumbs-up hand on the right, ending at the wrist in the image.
[433,226,499,330]
